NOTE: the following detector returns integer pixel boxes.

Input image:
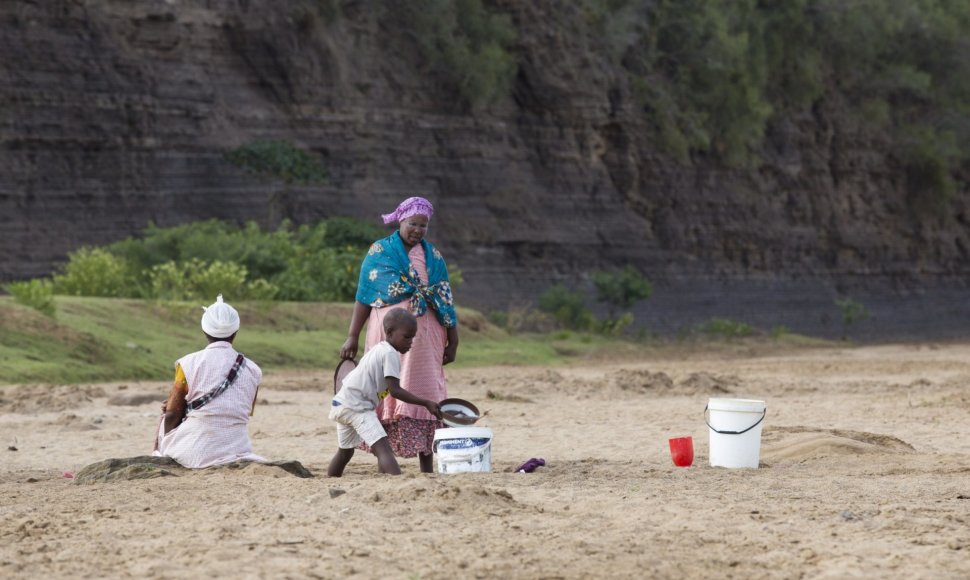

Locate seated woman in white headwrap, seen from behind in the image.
[152,294,266,468]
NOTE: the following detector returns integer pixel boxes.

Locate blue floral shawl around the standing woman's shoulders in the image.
[357,232,458,328]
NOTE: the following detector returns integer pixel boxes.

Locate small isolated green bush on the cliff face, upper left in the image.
[225,140,327,184]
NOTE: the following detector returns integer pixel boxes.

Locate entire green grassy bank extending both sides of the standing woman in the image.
[0,296,642,384]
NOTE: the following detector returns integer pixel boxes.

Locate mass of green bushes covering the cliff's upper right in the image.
[616,0,970,181]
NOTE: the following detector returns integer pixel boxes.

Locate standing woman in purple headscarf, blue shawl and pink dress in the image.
[340,197,458,473]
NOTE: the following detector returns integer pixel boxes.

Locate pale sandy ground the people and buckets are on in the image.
[0,344,970,579]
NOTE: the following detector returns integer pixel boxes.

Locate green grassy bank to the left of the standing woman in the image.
[0,296,350,383]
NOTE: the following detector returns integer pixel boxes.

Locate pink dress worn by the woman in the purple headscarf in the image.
[366,244,448,457]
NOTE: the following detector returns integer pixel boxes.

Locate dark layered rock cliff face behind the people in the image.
[0,0,970,337]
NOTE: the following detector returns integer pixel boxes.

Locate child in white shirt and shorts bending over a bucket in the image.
[327,308,441,477]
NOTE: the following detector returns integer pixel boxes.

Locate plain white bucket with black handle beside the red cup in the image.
[704,399,767,467]
